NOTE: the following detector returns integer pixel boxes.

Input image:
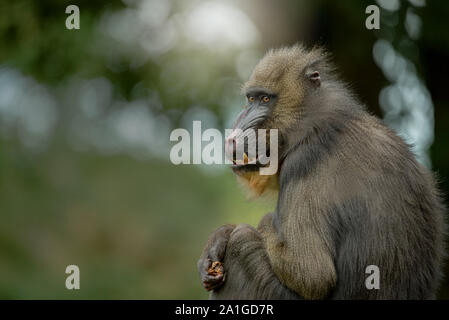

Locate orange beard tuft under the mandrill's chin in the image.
[234,170,279,197]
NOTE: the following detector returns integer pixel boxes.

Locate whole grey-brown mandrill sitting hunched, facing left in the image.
[198,45,446,299]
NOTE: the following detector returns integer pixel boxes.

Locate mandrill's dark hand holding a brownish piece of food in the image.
[198,224,235,291]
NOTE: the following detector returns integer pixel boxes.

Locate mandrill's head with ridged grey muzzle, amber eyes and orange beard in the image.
[225,45,332,196]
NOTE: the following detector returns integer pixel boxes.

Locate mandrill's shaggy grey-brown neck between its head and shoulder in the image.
[279,81,368,183]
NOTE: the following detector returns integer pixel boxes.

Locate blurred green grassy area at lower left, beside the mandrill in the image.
[0,134,272,299]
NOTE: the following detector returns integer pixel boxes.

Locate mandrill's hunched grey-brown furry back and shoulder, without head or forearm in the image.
[274,107,446,299]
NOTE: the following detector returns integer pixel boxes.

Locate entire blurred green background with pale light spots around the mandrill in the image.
[0,0,449,299]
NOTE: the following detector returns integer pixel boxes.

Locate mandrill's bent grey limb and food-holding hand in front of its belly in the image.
[198,224,300,299]
